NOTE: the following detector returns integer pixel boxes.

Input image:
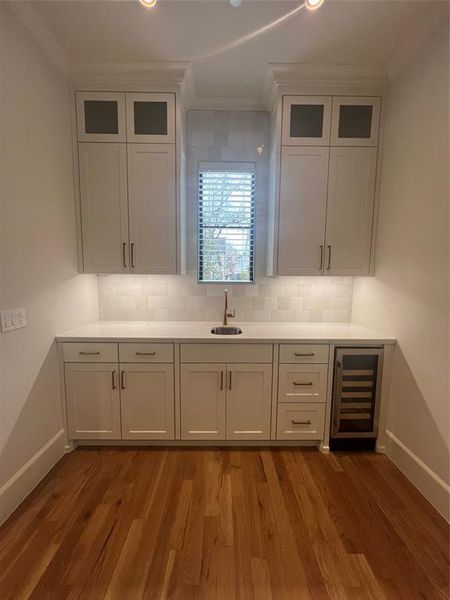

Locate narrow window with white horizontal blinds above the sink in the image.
[198,164,255,283]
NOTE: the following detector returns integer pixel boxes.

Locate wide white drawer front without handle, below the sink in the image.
[181,344,273,363]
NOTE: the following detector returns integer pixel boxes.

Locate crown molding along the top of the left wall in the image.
[8,0,70,75]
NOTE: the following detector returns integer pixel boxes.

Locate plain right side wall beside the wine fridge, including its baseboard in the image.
[353,20,449,516]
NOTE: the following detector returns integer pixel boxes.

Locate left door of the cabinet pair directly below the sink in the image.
[181,364,226,440]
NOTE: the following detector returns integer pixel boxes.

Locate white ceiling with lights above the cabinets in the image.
[33,0,446,102]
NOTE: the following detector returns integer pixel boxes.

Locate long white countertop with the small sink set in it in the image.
[56,320,395,344]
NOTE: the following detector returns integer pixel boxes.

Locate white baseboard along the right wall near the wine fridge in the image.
[386,429,450,522]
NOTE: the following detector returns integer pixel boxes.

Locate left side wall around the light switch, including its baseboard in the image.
[0,3,98,521]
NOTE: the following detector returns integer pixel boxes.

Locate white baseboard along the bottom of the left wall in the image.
[0,429,66,525]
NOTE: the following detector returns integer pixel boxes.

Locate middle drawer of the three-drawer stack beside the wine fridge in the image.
[278,365,328,402]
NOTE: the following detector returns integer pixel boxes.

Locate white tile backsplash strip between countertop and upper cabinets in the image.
[98,272,353,322]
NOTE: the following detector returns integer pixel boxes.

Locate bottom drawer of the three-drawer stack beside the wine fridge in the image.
[277,402,325,440]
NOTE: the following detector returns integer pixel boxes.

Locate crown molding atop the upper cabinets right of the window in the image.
[263,63,388,110]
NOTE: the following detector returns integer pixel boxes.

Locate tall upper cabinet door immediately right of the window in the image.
[278,146,329,275]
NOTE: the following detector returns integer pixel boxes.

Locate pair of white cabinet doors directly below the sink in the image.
[181,363,272,440]
